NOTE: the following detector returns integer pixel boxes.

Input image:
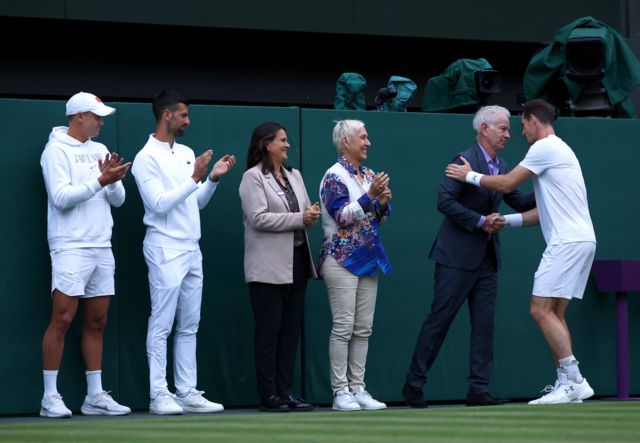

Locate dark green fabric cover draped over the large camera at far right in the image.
[523,17,640,118]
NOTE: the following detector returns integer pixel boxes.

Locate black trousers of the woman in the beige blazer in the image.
[249,245,309,398]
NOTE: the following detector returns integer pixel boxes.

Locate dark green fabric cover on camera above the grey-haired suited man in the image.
[422,58,492,112]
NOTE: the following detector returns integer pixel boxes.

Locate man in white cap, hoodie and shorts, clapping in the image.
[40,92,131,418]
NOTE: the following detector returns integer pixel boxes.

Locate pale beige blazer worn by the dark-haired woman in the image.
[240,164,318,284]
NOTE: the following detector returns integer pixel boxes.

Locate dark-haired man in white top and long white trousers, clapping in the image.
[131,91,236,414]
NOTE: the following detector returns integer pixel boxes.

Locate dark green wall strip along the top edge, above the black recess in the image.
[0,0,621,42]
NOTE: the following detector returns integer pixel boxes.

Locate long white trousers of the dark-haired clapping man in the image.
[143,245,203,399]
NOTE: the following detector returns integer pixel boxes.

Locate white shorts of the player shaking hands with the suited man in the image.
[533,242,596,300]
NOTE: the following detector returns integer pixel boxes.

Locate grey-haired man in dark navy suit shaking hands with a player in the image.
[402,106,535,408]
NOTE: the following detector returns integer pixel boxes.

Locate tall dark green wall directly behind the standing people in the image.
[0,100,640,414]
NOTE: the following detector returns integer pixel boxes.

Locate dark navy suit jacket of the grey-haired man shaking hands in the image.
[429,143,536,271]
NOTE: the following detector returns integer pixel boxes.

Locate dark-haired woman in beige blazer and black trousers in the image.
[240,122,320,412]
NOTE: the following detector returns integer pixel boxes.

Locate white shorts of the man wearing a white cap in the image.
[50,248,116,298]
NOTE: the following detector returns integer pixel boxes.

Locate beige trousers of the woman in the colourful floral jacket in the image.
[321,255,378,394]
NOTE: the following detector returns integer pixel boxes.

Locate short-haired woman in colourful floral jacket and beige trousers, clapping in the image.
[318,120,391,411]
